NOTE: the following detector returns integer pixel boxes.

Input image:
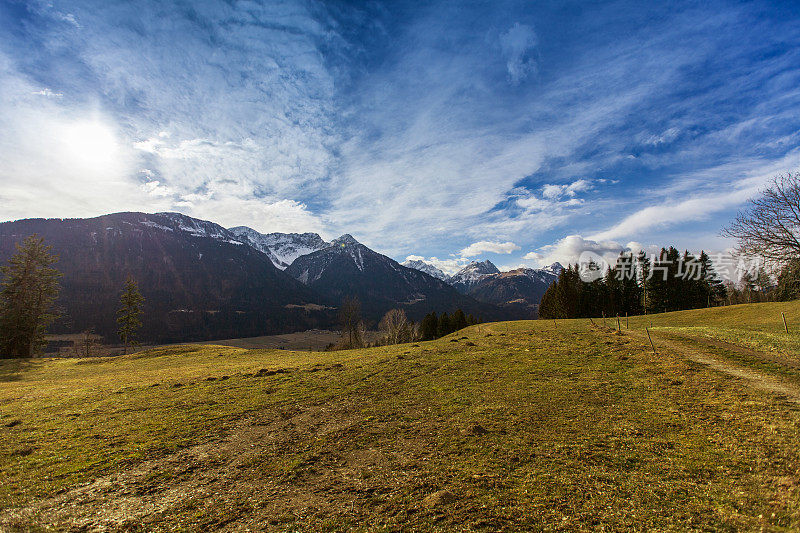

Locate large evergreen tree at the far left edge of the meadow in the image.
[0,235,61,357]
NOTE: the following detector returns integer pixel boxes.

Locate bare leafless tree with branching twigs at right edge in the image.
[722,173,800,264]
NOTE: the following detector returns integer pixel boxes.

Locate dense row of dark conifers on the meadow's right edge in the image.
[539,246,727,319]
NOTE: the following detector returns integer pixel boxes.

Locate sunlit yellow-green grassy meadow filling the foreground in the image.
[0,302,800,531]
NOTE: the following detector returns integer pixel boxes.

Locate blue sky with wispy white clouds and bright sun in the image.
[0,0,800,269]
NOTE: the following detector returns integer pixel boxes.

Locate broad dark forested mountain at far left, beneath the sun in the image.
[0,213,333,341]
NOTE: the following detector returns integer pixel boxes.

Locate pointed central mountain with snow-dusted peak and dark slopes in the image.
[285,235,505,321]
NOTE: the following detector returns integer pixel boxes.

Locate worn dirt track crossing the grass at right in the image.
[626,330,800,405]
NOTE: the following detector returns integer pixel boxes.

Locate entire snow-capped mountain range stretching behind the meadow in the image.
[0,213,557,342]
